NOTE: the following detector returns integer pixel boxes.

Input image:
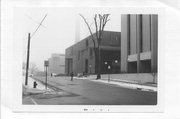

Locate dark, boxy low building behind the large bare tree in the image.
[65,31,120,75]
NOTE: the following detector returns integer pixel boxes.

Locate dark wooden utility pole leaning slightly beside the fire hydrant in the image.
[25,33,31,85]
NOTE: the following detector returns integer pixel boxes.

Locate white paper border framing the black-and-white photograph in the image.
[4,2,165,112]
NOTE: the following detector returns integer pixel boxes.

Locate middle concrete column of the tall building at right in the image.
[136,15,142,73]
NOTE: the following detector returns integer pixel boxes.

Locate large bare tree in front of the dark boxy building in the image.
[80,14,110,79]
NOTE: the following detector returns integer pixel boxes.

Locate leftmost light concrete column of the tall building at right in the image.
[120,14,130,73]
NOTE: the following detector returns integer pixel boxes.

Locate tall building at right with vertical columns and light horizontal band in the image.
[121,14,158,73]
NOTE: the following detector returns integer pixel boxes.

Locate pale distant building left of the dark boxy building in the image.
[48,54,65,75]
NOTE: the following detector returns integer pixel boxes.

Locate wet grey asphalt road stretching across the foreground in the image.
[23,77,157,105]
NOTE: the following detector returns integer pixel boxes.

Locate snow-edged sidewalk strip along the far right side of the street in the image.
[74,75,157,92]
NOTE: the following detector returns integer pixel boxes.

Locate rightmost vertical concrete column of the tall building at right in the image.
[150,15,158,73]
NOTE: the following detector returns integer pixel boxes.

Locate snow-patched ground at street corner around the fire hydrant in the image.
[23,77,52,96]
